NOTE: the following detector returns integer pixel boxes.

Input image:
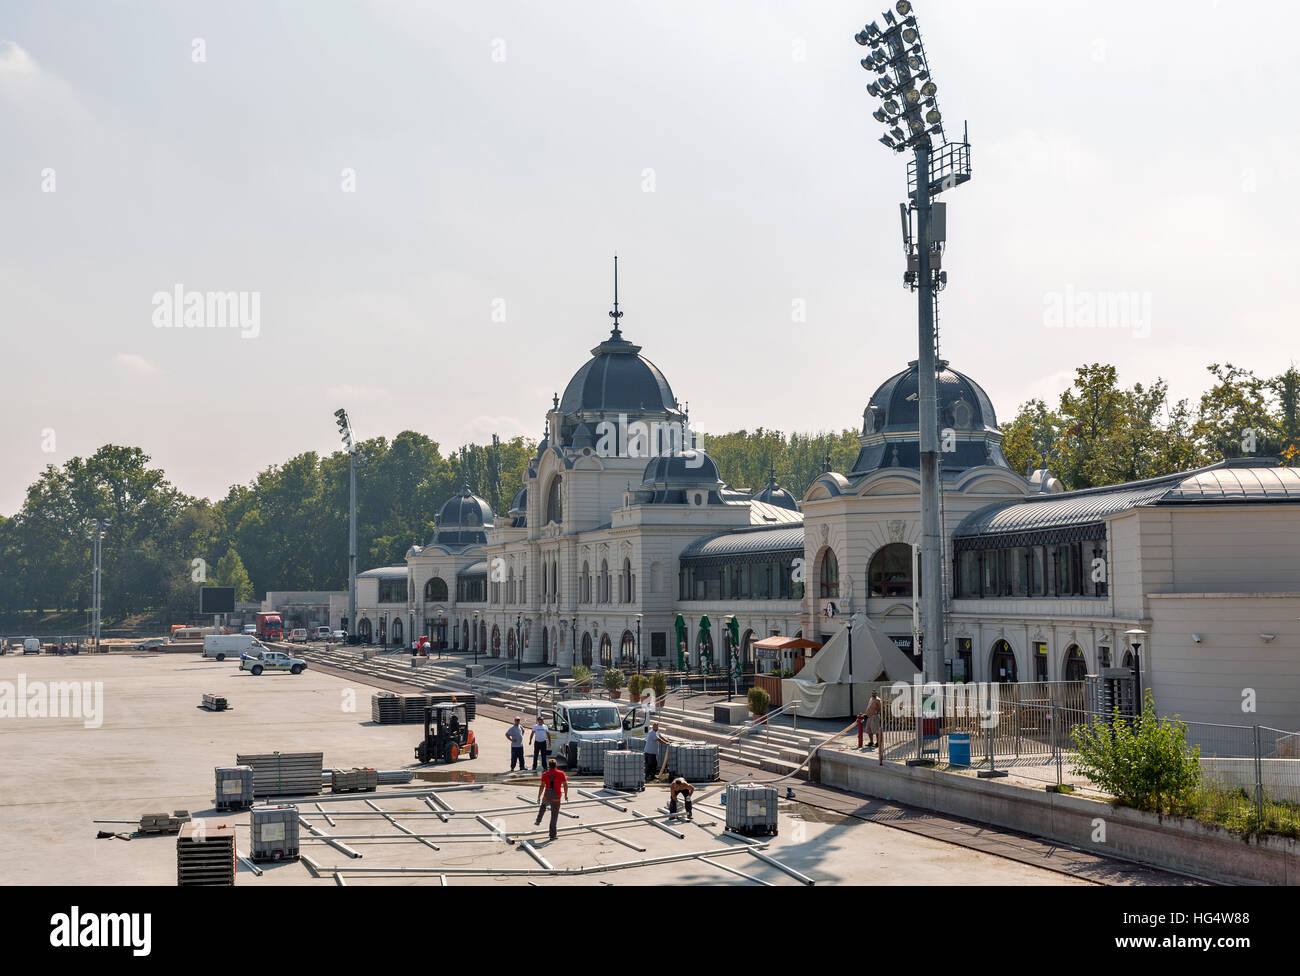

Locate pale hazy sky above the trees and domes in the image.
[0,0,1300,515]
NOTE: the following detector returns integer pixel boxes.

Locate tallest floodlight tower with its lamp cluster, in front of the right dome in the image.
[854,0,971,681]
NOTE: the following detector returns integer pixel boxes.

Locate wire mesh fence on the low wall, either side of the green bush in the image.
[879,681,1300,834]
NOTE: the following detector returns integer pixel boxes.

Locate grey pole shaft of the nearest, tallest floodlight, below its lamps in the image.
[915,146,944,681]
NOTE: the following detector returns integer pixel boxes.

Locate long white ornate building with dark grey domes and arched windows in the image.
[333,306,1300,729]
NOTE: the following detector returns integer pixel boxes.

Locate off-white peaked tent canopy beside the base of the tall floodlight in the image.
[781,613,918,719]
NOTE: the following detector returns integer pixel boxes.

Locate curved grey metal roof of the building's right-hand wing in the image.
[953,457,1300,548]
